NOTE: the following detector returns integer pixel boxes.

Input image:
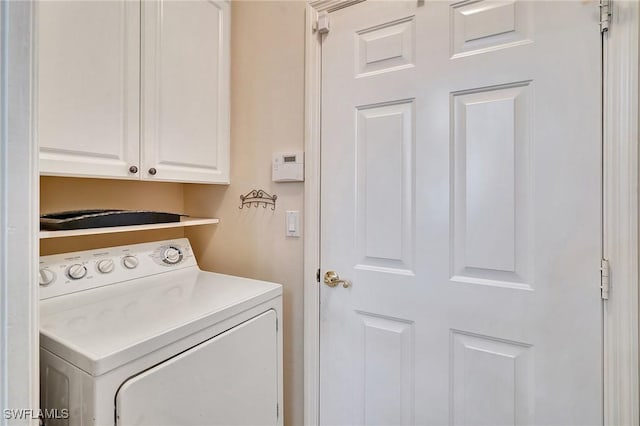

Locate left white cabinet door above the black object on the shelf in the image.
[35,0,140,178]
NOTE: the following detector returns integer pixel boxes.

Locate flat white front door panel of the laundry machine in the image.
[115,310,280,426]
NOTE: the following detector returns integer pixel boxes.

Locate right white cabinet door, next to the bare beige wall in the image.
[141,0,230,183]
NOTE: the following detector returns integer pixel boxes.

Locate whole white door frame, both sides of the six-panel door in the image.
[303,0,640,426]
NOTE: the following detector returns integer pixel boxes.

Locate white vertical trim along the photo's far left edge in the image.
[0,0,39,425]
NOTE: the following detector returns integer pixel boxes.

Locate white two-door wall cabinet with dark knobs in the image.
[36,0,230,183]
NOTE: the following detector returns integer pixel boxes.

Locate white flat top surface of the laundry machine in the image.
[40,267,282,376]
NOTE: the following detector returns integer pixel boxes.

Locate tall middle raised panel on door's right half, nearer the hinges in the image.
[451,82,533,288]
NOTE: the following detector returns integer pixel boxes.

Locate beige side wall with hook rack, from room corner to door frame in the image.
[184,1,305,426]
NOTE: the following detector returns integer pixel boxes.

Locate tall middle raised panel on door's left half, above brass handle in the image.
[356,101,414,273]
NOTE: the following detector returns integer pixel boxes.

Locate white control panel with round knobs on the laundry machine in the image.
[38,238,198,299]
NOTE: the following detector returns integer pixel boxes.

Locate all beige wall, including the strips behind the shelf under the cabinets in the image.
[40,1,305,426]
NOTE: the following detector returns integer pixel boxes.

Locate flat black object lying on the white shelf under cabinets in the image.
[40,209,186,231]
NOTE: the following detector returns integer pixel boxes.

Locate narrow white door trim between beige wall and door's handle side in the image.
[304,4,322,426]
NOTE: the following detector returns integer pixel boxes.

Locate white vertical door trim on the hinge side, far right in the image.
[603,1,640,426]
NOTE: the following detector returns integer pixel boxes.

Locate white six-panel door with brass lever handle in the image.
[320,0,603,425]
